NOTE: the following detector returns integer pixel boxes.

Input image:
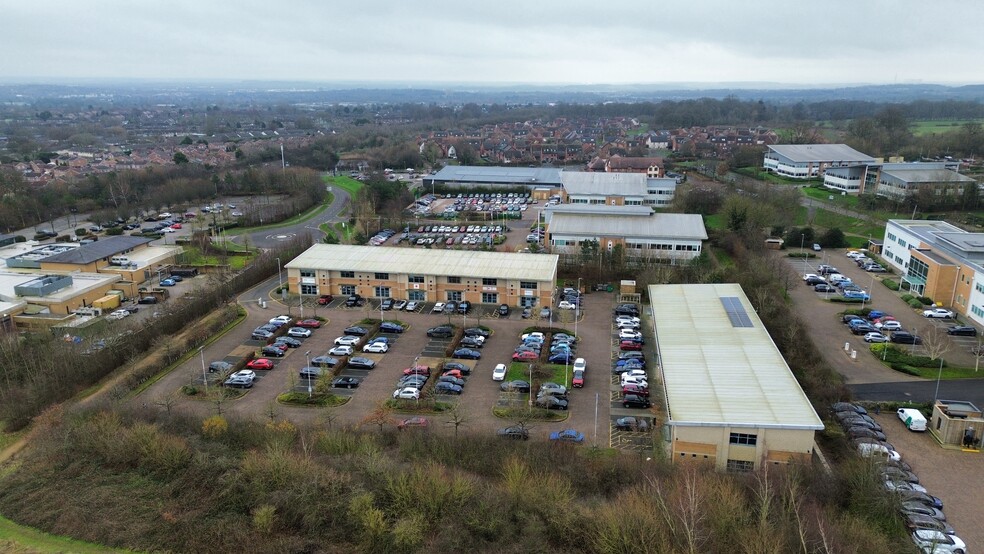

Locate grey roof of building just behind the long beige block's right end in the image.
[547,213,707,240]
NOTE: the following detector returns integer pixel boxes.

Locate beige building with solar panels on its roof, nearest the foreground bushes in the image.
[649,284,824,471]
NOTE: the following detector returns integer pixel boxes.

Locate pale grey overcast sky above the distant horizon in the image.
[0,0,984,85]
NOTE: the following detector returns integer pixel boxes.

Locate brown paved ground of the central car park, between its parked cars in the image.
[145,283,653,449]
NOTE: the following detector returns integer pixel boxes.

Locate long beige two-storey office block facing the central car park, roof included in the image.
[286,244,558,306]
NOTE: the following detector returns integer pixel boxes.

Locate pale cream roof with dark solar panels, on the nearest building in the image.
[649,283,824,431]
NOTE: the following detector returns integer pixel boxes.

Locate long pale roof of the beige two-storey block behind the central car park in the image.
[285,244,559,281]
